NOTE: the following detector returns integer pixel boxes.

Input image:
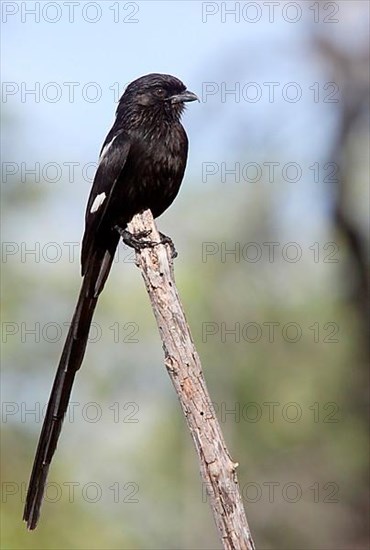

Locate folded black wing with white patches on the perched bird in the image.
[81,130,131,275]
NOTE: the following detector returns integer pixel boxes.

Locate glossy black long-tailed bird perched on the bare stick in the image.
[23,74,198,529]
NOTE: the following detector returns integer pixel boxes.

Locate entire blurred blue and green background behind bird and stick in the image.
[1,0,369,550]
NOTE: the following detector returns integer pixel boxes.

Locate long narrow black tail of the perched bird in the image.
[23,244,118,529]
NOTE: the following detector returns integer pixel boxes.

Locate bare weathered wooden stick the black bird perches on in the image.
[128,210,255,550]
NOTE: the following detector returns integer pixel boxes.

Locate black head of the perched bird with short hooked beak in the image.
[117,73,199,124]
